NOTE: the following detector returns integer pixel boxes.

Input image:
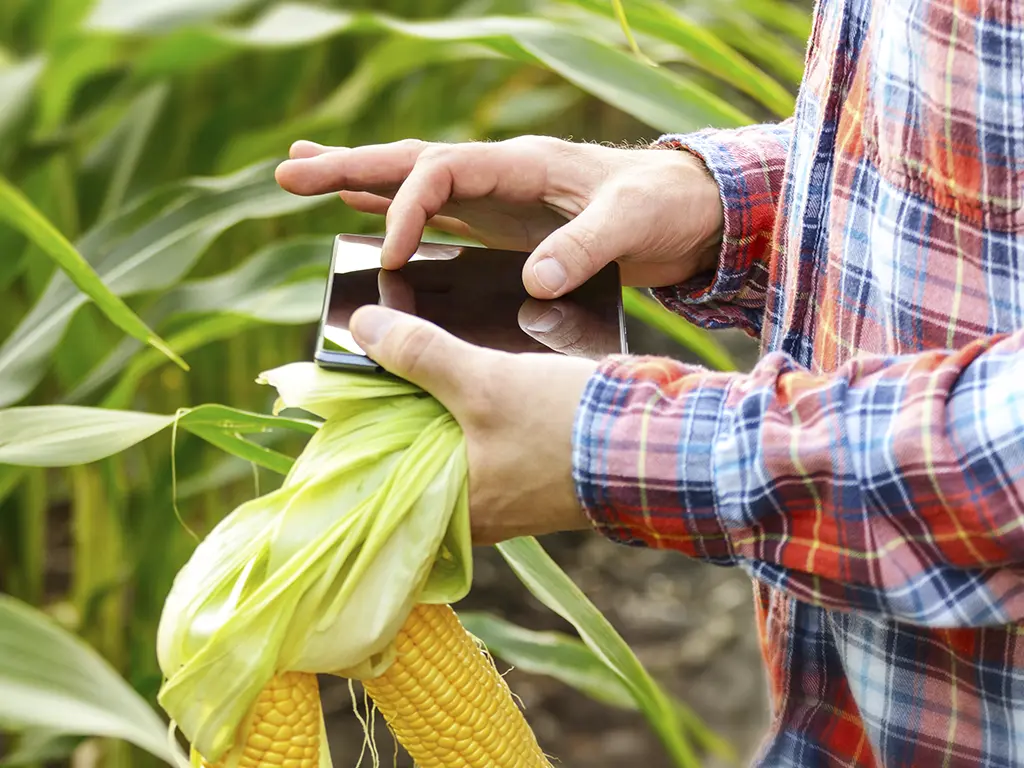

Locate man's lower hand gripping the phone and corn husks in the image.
[349,306,597,544]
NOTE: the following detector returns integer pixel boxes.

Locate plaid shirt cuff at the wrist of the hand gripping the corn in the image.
[572,355,736,565]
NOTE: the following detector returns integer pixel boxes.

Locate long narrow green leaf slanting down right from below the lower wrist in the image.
[497,538,700,768]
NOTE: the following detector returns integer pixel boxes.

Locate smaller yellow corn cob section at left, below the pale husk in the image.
[203,672,323,768]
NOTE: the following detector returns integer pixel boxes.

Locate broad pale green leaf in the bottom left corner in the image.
[0,595,187,766]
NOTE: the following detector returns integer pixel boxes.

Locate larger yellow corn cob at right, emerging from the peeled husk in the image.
[362,605,550,768]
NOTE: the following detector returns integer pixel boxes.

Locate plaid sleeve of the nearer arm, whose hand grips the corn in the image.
[573,333,1024,627]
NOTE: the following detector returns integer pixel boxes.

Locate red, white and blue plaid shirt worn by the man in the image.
[574,0,1024,768]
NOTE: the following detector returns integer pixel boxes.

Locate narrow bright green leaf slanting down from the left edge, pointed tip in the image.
[0,178,188,371]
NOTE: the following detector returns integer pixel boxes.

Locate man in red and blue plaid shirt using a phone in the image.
[279,0,1024,767]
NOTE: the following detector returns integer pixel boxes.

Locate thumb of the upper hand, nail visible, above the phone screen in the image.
[522,195,636,299]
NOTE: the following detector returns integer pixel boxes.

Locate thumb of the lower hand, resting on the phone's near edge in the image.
[348,305,468,411]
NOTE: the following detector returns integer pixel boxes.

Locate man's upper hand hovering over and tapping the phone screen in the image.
[278,136,723,299]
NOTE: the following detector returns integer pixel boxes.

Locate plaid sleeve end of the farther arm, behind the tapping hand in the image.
[652,120,793,336]
